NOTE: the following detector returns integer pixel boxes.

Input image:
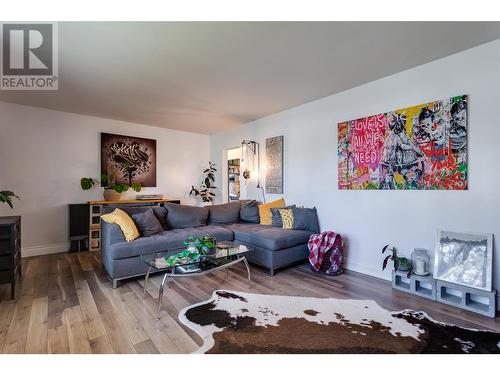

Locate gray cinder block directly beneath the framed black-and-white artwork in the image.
[436,280,496,318]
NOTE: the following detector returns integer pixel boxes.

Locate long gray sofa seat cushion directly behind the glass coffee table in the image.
[111,225,234,259]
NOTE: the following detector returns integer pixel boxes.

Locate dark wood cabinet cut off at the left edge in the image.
[0,216,21,299]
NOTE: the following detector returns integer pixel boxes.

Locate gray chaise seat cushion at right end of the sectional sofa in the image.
[226,223,312,251]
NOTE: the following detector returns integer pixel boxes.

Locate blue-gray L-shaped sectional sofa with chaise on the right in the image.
[101,201,314,288]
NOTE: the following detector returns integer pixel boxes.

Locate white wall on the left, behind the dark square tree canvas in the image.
[0,101,210,256]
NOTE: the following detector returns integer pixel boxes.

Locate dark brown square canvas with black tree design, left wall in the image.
[101,133,156,187]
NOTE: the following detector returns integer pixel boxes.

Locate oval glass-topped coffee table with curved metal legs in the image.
[141,241,252,320]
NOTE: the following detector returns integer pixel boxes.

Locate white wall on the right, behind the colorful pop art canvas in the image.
[211,40,500,298]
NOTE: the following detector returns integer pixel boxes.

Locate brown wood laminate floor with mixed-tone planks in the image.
[0,252,500,353]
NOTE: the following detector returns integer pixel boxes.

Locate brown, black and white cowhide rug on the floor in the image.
[179,290,500,353]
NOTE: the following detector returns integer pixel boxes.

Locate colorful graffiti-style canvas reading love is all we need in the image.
[338,95,468,190]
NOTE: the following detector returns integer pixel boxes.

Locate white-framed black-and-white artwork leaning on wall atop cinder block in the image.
[434,230,493,291]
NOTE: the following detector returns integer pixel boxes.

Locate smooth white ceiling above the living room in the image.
[0,22,500,134]
